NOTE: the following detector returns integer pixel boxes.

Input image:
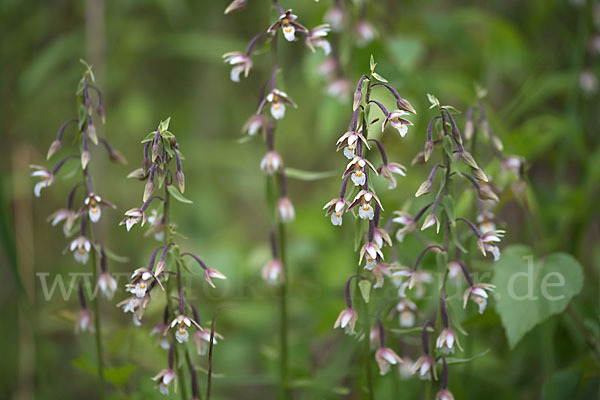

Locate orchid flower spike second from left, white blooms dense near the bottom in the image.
[118,119,226,394]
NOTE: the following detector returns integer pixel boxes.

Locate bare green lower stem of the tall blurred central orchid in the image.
[277,223,292,400]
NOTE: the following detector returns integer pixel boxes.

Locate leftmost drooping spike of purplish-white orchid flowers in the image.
[31,61,124,334]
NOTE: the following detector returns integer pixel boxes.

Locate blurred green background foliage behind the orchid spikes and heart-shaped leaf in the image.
[0,0,600,399]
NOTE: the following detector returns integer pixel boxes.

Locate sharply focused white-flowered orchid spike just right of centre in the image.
[324,61,415,375]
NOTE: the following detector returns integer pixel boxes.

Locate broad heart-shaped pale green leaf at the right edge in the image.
[492,245,583,348]
